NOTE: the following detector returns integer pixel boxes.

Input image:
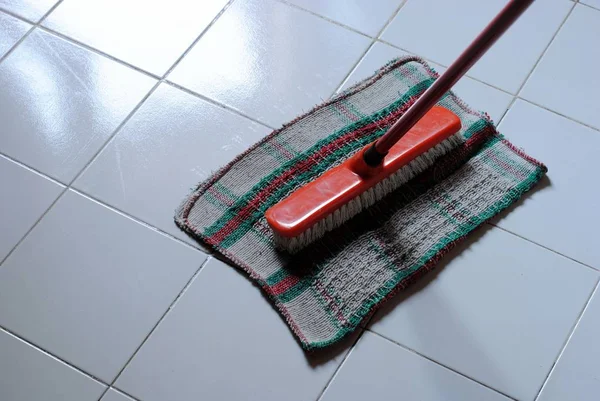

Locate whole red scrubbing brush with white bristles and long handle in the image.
[265,0,533,253]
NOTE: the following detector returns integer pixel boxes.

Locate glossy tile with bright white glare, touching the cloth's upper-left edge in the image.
[169,0,370,126]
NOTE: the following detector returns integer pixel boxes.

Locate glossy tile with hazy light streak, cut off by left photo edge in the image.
[0,30,155,183]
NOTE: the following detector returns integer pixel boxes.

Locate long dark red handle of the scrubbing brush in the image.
[364,0,533,166]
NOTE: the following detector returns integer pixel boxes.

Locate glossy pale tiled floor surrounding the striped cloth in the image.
[0,0,600,401]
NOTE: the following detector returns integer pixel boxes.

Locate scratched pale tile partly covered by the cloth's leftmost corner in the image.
[75,84,269,243]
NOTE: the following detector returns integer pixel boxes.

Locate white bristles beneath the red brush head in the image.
[273,134,462,253]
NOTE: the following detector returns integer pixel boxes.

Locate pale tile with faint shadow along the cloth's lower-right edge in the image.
[372,227,598,400]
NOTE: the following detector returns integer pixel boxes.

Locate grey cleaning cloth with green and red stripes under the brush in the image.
[175,57,546,349]
